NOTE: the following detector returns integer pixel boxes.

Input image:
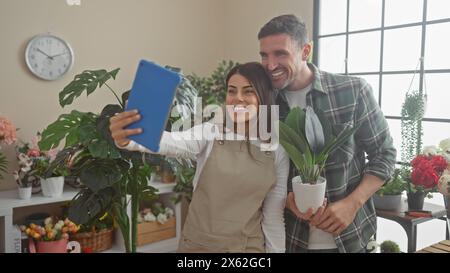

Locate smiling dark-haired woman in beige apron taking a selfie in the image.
[110,63,289,252]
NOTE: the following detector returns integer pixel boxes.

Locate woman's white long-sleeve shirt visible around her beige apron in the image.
[122,123,289,252]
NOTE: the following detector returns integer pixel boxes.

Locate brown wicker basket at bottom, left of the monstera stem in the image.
[70,226,114,252]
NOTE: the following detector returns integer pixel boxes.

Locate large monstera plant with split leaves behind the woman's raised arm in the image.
[39,67,197,252]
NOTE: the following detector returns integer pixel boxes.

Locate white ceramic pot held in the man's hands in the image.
[292,176,327,213]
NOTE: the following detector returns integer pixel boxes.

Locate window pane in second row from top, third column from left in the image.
[383,26,422,71]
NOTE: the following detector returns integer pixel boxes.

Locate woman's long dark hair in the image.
[226,62,274,158]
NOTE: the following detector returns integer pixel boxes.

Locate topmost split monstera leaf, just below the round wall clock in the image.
[59,68,119,107]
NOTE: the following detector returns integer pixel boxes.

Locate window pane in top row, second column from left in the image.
[349,0,382,31]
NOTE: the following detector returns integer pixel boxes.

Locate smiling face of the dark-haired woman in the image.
[225,74,259,123]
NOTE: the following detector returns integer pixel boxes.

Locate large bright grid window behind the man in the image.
[313,0,450,162]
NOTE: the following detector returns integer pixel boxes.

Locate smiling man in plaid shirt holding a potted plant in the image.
[258,15,396,252]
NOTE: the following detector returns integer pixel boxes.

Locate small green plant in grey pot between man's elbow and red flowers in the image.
[373,169,407,211]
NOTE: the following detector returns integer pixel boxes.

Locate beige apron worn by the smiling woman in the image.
[178,140,276,252]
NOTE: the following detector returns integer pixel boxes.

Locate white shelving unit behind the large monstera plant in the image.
[0,182,181,253]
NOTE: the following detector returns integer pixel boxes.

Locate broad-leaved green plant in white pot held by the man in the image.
[279,106,358,213]
